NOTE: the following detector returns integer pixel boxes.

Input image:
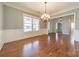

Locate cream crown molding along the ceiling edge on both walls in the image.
[3,2,79,19]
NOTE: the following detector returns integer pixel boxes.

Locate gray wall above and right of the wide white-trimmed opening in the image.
[52,8,79,29]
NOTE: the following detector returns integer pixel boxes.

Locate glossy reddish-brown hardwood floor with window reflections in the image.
[0,33,76,57]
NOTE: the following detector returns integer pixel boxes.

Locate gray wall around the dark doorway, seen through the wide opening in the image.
[50,17,69,34]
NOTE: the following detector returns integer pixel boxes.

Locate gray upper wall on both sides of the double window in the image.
[3,5,46,29]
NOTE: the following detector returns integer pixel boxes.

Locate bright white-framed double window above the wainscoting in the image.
[24,16,40,32]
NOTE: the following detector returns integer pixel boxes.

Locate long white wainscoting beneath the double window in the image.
[3,29,47,43]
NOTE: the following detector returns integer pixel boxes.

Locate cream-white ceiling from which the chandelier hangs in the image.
[3,2,79,15]
